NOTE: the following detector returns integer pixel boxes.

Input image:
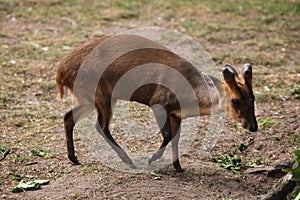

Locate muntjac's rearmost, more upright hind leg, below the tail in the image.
[64,105,93,165]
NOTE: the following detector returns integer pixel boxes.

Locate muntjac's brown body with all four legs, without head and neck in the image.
[57,35,215,171]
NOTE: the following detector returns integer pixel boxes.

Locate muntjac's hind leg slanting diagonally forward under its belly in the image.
[96,101,137,169]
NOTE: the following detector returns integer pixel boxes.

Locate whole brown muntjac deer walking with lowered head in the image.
[56,35,258,171]
